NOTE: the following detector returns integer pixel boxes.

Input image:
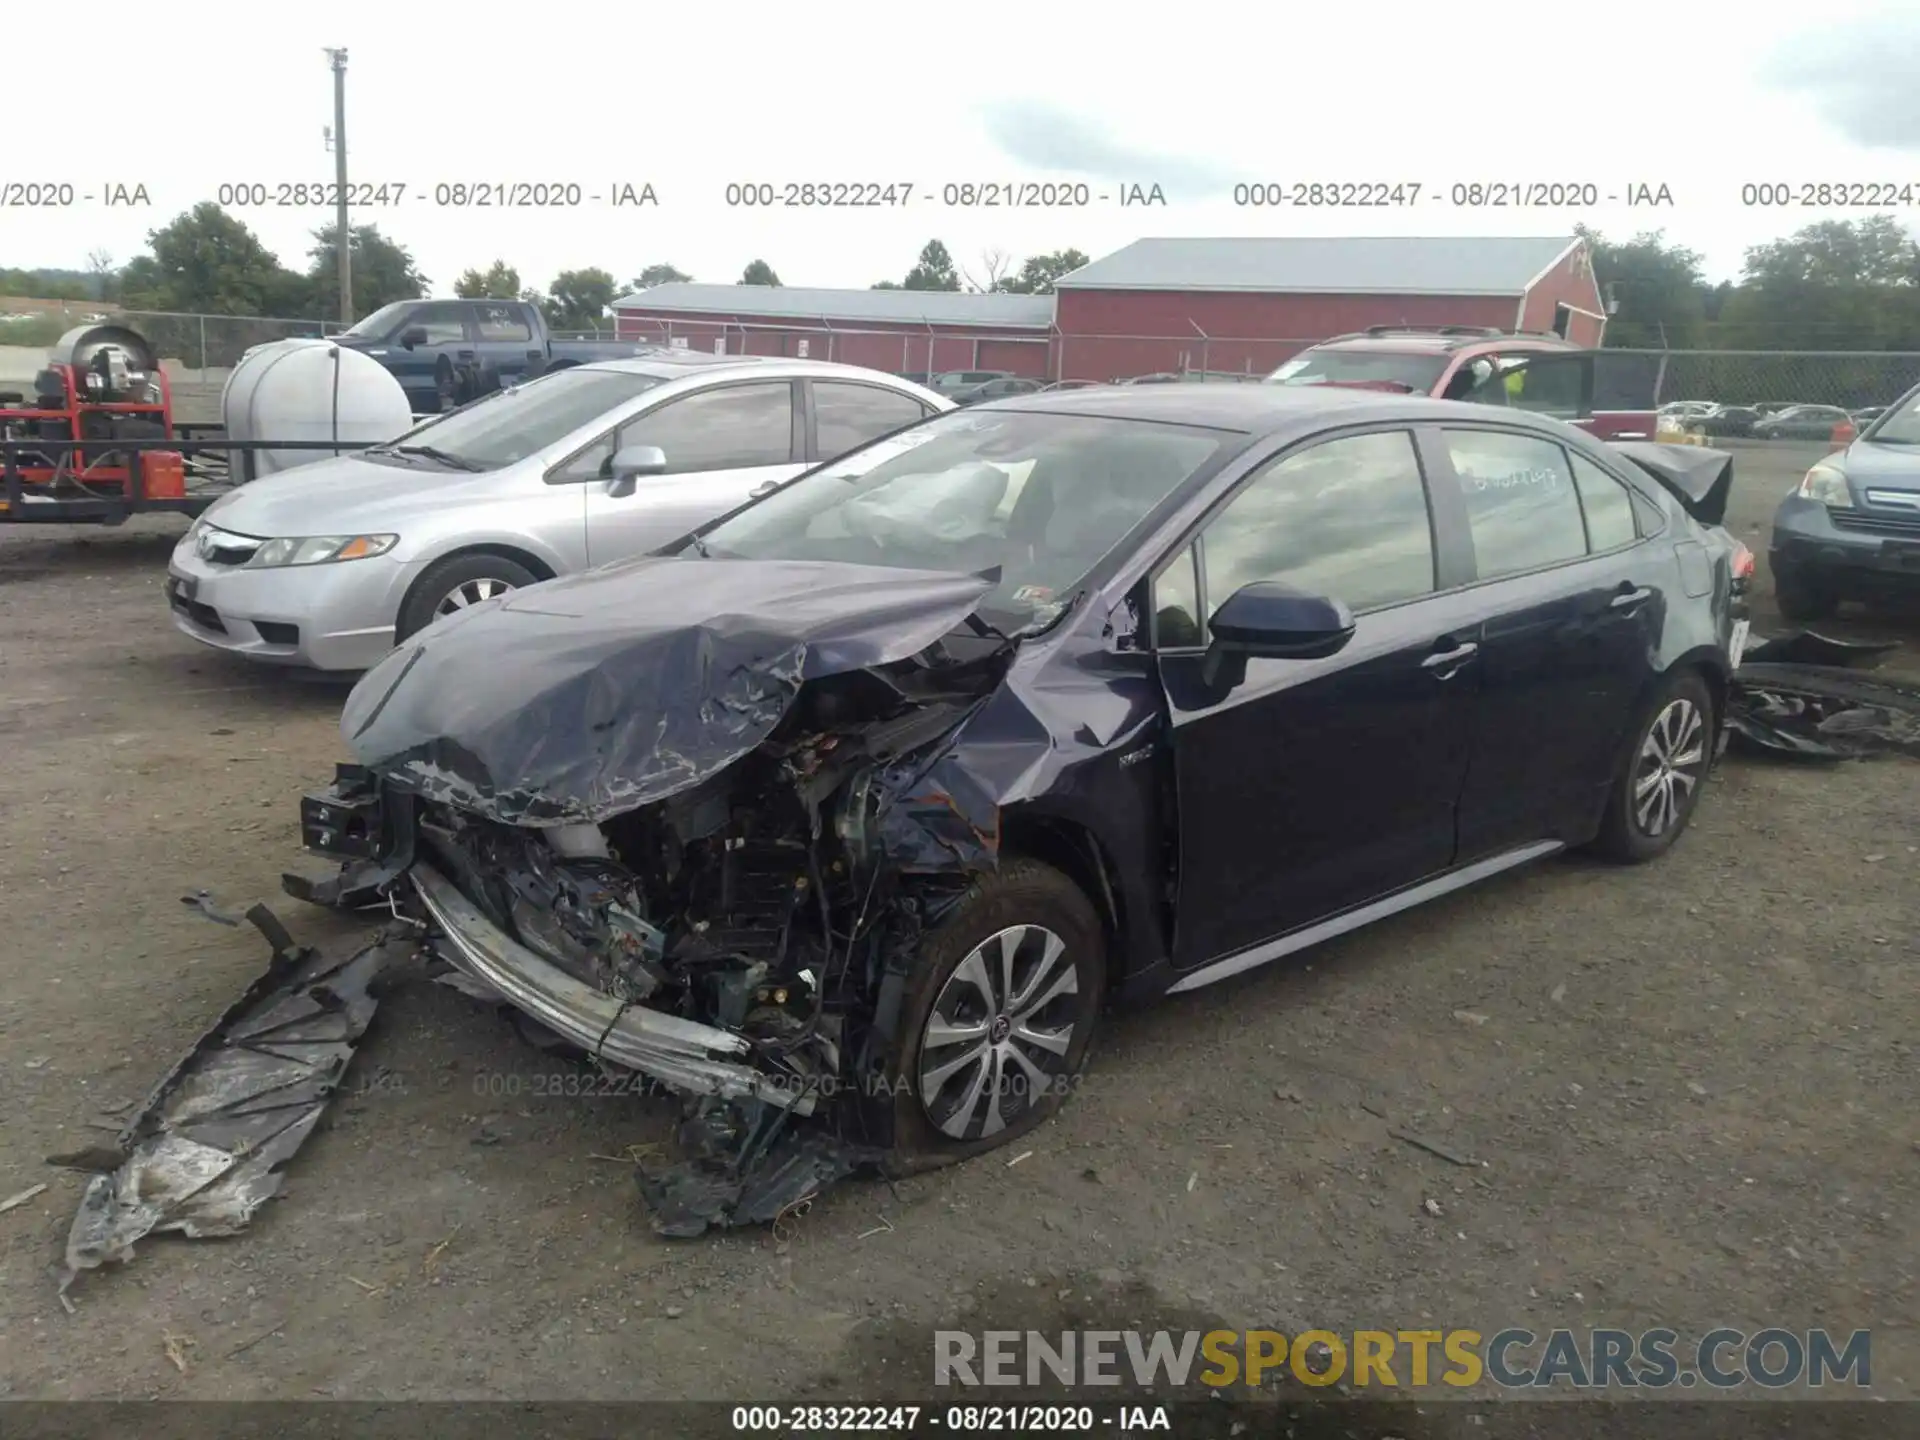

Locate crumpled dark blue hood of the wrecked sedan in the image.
[340,559,993,824]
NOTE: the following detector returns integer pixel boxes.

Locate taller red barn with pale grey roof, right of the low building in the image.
[1054,236,1607,380]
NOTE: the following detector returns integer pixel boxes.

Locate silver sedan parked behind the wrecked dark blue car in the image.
[167,360,952,670]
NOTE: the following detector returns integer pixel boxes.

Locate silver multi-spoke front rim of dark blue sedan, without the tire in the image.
[920,925,1085,1140]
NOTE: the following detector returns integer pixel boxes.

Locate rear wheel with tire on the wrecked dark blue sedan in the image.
[1594,670,1720,864]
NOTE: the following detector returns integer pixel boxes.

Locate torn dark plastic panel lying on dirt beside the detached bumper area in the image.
[50,904,411,1302]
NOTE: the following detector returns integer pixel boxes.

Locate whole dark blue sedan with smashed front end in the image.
[288,386,1751,1235]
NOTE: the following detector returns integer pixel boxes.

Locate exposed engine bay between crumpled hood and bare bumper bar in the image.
[419,664,993,1081]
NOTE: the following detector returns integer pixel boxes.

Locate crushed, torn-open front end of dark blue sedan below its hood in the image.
[286,568,1012,1235]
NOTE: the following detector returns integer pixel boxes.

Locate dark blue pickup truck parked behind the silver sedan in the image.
[332,300,649,415]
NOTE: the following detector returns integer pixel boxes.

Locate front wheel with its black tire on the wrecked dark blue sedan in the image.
[889,860,1106,1173]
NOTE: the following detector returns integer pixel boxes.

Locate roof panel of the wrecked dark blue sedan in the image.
[968,382,1580,438]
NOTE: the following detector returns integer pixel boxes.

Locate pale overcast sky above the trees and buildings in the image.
[11,0,1920,294]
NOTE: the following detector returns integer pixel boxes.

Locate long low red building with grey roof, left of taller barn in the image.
[612,282,1054,380]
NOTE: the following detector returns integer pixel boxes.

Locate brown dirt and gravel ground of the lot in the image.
[0,453,1920,1400]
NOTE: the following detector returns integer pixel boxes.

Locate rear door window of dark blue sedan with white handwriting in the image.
[1442,430,1586,580]
